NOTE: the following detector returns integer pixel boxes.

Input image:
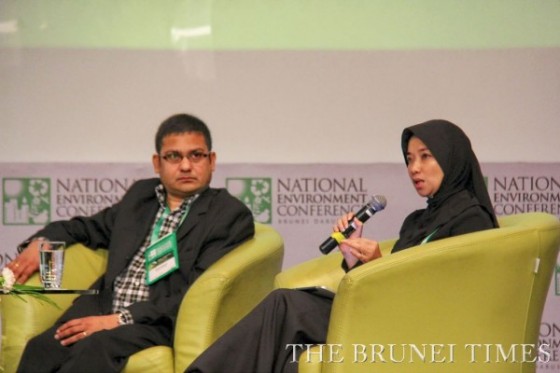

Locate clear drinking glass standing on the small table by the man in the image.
[39,240,66,289]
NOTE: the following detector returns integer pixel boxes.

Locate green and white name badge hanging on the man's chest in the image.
[144,232,179,285]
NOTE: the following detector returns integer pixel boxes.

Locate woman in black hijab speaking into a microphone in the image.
[185,120,498,373]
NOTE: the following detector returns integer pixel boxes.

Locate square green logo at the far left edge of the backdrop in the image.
[2,178,51,225]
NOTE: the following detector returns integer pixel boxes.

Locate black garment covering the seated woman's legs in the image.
[185,289,332,373]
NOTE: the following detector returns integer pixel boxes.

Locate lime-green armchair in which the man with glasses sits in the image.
[0,223,284,373]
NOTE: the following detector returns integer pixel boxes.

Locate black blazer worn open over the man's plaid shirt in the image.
[32,178,254,327]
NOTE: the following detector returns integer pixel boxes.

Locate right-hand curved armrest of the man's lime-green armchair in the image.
[174,223,284,372]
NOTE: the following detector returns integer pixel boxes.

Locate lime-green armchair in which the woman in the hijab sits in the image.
[275,213,560,373]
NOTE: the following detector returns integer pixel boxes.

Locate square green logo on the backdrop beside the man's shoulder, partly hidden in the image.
[226,177,272,224]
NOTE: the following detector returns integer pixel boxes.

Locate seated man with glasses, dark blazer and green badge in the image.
[8,114,254,372]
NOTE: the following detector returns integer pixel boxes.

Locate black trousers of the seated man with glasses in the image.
[17,296,171,373]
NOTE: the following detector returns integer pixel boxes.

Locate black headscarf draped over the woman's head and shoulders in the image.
[394,120,498,251]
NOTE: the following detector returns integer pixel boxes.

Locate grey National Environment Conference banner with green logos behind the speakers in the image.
[0,163,560,372]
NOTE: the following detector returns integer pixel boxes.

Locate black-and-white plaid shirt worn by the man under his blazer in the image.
[113,184,198,324]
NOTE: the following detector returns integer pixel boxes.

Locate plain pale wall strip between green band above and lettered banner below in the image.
[0,48,560,163]
